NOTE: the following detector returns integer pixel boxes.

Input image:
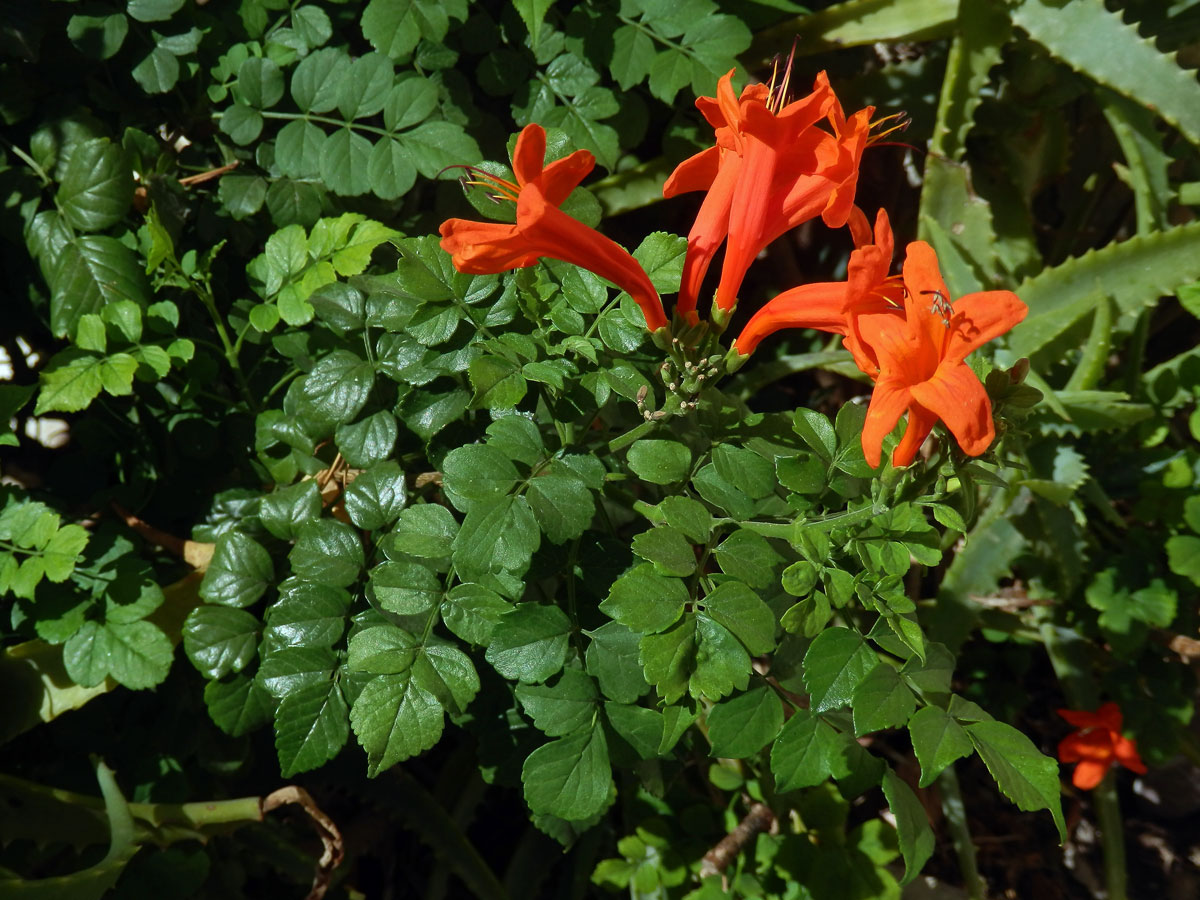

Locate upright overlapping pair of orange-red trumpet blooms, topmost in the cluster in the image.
[662,71,874,320]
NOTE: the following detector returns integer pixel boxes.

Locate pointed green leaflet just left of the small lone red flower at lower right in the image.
[965,722,1067,840]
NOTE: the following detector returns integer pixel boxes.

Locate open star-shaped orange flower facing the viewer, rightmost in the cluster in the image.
[856,241,1028,467]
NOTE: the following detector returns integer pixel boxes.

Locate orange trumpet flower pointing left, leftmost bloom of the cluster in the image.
[440,124,667,331]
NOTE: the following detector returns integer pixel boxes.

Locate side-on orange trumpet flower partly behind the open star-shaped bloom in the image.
[733,208,904,362]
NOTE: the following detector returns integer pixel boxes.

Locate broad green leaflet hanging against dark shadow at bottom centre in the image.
[521,722,612,821]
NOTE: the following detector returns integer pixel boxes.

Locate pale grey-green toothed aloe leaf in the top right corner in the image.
[1012,0,1200,144]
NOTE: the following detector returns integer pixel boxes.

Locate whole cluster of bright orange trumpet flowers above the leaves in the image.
[440,66,1026,467]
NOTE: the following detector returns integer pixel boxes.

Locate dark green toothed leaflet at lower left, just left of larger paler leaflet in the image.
[275,682,350,778]
